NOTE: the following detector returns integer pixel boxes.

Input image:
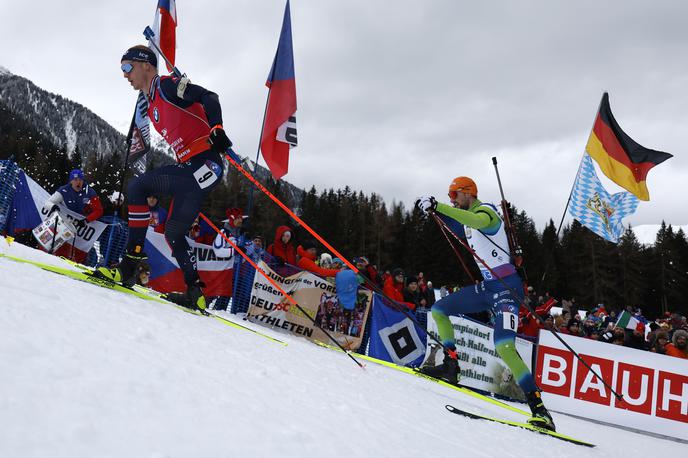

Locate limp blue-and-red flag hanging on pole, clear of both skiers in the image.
[260,0,297,180]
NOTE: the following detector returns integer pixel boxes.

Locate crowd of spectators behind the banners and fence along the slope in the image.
[14,169,688,359]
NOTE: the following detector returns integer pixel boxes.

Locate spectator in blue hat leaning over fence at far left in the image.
[43,169,103,262]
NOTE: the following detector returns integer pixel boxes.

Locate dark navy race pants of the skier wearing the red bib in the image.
[127,150,223,285]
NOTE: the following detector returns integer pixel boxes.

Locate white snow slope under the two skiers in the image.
[0,238,685,458]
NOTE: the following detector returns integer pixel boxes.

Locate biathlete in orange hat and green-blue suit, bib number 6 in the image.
[416,177,554,430]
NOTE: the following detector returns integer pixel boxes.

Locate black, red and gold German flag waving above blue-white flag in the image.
[585,92,672,200]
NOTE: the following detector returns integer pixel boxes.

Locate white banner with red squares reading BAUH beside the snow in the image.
[535,330,688,440]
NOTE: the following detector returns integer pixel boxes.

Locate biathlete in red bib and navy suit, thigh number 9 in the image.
[99,46,232,309]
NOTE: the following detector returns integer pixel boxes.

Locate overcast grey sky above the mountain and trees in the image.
[0,0,688,228]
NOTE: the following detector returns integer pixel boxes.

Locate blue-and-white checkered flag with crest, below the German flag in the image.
[569,154,640,243]
